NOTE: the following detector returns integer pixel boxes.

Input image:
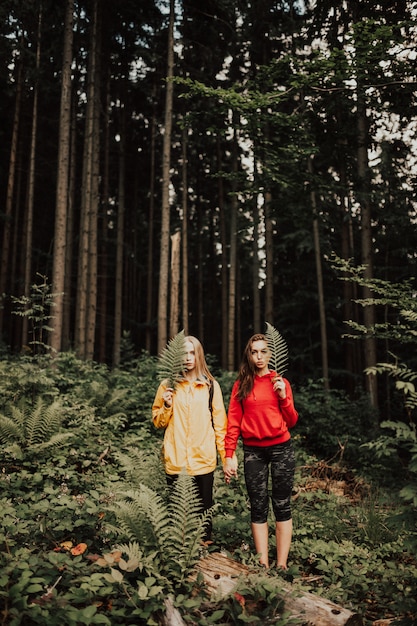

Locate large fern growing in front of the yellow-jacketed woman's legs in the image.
[109,474,212,588]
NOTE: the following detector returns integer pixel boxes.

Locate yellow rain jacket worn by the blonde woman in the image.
[152,380,227,476]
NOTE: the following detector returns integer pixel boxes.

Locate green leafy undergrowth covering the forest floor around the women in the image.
[0,354,417,626]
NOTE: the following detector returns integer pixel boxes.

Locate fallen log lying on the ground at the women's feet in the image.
[194,552,363,626]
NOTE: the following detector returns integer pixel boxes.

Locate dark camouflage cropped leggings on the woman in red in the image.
[243,440,295,524]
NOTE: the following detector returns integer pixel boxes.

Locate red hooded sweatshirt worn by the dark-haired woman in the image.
[225,371,298,457]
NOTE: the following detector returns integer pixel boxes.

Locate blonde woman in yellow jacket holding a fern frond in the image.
[152,336,227,541]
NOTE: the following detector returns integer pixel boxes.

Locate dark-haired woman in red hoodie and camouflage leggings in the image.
[223,334,298,570]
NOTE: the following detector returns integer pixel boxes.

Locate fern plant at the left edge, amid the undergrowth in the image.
[0,397,73,459]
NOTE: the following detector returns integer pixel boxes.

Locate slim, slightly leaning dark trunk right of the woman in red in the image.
[308,157,330,391]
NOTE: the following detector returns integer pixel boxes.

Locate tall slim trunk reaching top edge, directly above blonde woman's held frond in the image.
[158,0,175,354]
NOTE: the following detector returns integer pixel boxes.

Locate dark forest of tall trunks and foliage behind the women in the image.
[0,0,417,405]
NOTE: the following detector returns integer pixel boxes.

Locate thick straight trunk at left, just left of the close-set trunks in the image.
[49,0,74,353]
